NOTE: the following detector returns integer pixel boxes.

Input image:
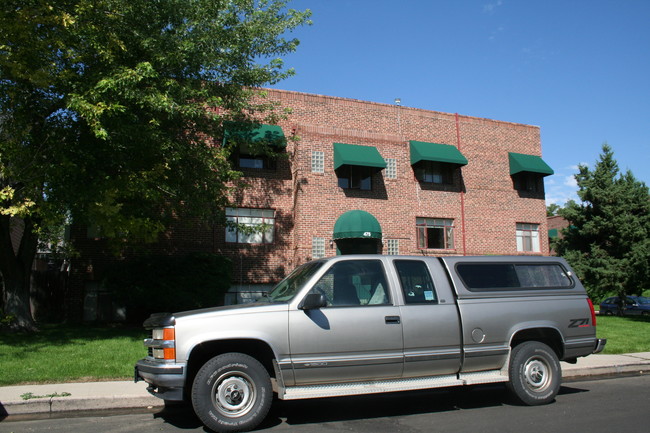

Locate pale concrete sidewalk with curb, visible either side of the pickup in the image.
[0,352,650,420]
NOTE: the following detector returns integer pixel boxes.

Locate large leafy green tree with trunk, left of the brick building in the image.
[0,0,310,328]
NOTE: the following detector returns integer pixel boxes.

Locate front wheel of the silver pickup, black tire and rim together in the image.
[192,353,273,432]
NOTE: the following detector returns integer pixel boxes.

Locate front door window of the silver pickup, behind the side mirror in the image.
[310,260,390,307]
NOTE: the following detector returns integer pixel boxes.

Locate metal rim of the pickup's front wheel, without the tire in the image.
[212,371,256,418]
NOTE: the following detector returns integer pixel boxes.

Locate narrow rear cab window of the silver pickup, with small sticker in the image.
[393,260,438,304]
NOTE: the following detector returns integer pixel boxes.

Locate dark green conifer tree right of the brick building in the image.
[556,144,650,299]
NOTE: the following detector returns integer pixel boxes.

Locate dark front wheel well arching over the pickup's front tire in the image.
[185,339,275,396]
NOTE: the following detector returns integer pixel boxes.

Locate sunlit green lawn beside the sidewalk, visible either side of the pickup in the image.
[0,316,650,386]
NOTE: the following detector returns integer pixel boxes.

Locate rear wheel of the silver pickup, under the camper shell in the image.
[508,341,562,406]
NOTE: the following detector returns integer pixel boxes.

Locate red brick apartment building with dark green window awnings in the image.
[68,90,553,318]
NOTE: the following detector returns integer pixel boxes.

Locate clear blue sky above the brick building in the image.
[274,0,650,204]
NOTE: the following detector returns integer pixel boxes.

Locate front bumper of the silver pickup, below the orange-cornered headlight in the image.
[134,358,187,401]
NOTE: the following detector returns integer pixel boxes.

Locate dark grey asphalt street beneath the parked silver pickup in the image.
[0,374,650,433]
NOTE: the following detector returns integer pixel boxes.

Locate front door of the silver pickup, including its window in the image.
[289,259,403,385]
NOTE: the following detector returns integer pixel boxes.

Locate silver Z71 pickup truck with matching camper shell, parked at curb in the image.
[135,255,605,432]
